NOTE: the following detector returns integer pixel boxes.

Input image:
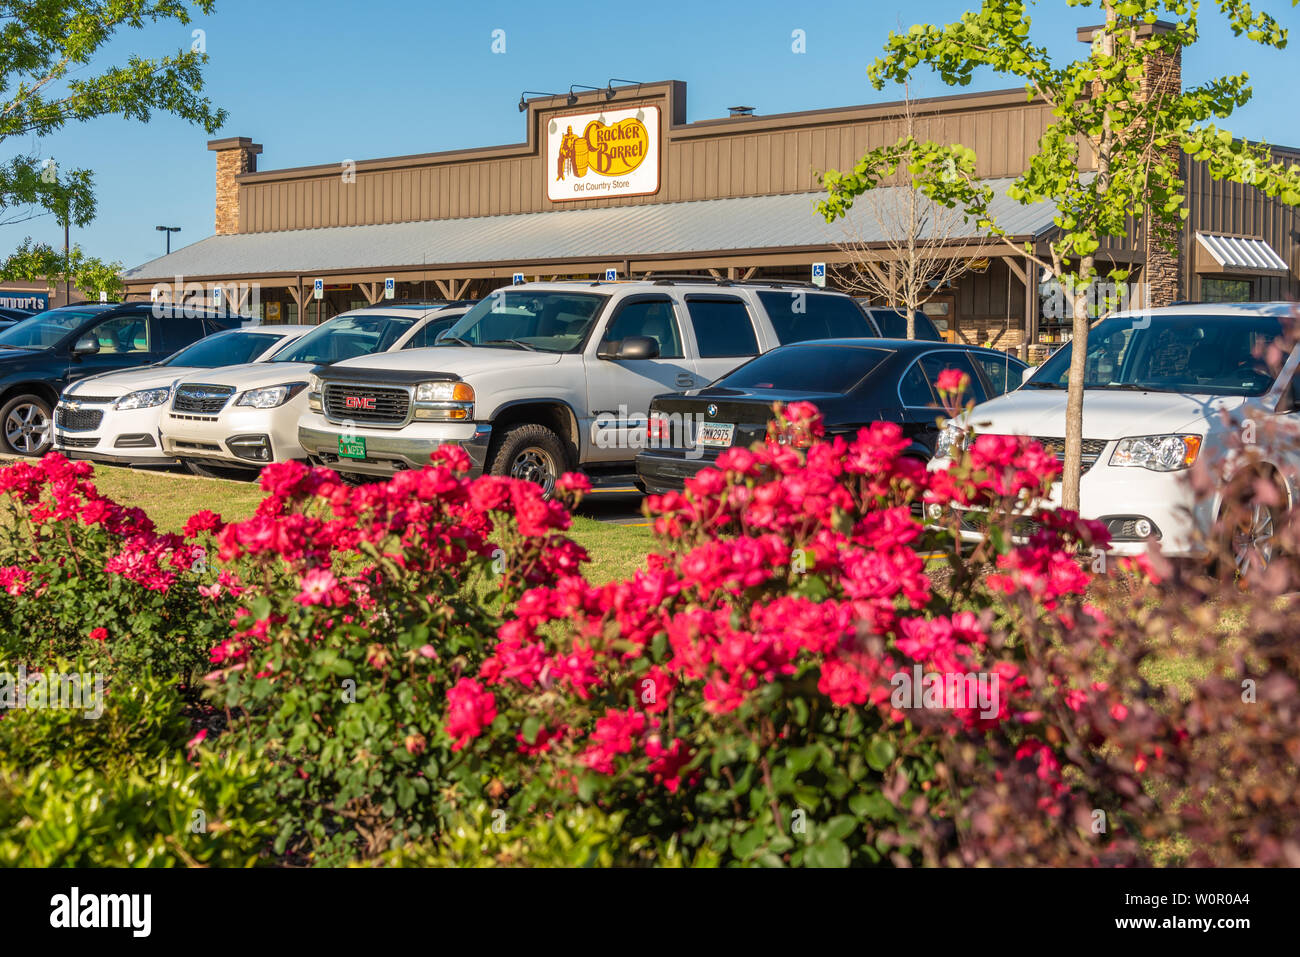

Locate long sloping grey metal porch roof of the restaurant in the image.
[125,179,1056,282]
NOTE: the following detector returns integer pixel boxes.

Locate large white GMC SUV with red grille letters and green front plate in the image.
[298,277,880,492]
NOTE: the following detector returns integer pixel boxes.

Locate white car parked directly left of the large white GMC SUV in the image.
[161,303,469,477]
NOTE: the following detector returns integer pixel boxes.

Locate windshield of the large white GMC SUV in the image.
[438,287,607,352]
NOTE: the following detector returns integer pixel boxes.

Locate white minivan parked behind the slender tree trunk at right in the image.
[931,303,1300,570]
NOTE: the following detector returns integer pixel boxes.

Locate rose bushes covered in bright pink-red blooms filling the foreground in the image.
[0,395,1300,866]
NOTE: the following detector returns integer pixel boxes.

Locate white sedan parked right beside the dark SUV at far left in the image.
[55,325,316,465]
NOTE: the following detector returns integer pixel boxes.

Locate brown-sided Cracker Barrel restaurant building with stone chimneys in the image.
[125,31,1300,348]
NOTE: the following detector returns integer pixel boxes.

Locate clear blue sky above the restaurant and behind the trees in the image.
[10,0,1300,267]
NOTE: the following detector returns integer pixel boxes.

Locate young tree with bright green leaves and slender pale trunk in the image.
[820,0,1300,508]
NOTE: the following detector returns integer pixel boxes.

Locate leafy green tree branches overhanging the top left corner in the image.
[0,0,226,293]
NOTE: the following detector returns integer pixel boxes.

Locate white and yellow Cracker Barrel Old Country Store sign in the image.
[546,107,659,203]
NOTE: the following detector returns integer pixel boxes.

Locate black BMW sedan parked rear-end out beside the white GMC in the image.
[637,339,1028,493]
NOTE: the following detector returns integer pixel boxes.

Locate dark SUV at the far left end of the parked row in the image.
[0,303,239,455]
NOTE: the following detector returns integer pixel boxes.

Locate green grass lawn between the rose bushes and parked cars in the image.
[74,465,653,583]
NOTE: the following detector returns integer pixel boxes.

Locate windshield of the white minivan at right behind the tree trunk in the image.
[1026,310,1282,395]
